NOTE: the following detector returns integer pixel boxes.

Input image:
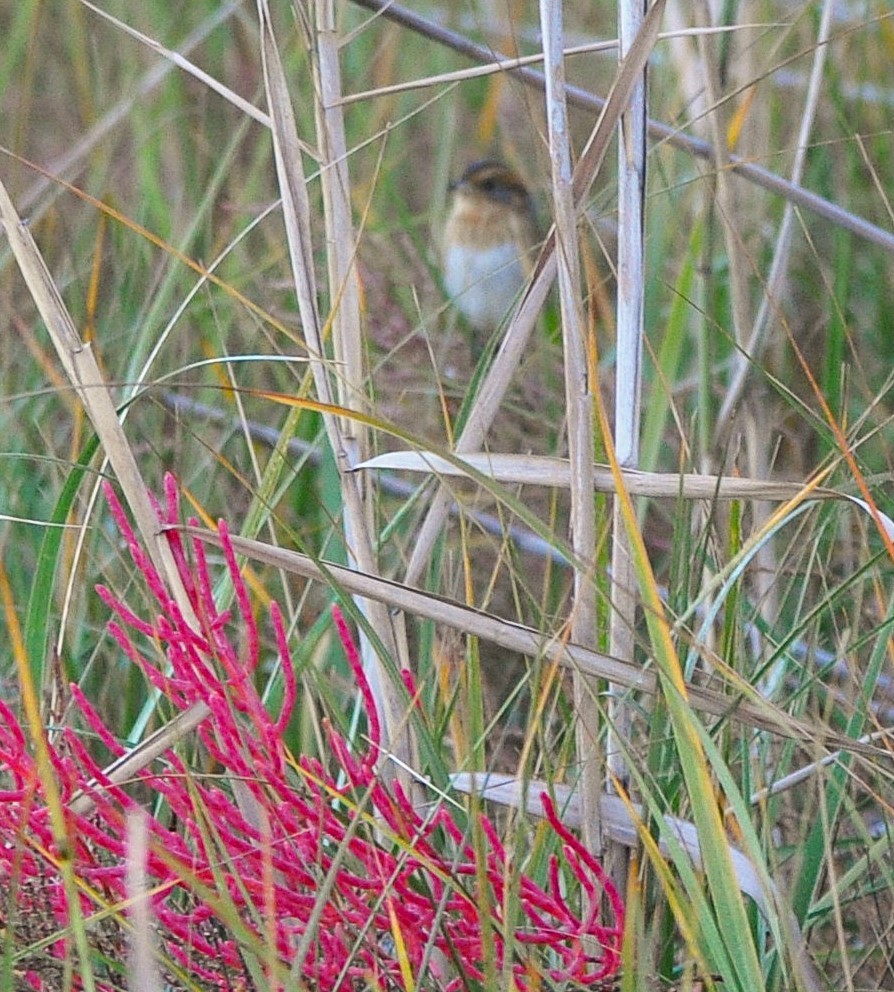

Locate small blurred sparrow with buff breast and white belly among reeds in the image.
[443,160,541,346]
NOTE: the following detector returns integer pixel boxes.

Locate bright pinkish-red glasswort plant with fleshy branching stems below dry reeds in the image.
[0,478,623,992]
